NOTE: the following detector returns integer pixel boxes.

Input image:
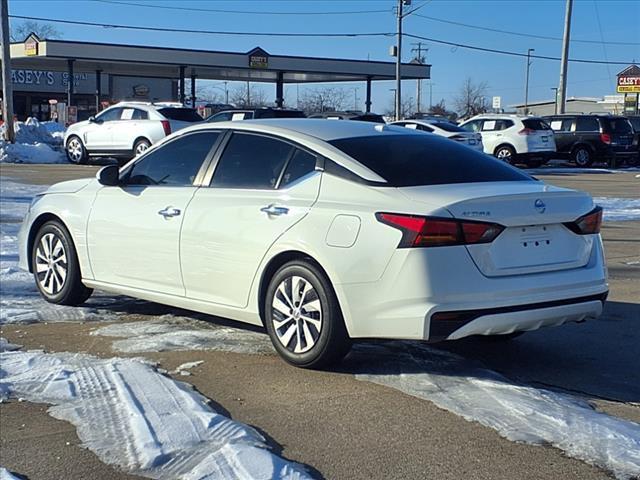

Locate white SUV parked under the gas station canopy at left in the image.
[64,102,203,163]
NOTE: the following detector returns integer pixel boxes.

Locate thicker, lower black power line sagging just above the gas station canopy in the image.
[9,15,395,37]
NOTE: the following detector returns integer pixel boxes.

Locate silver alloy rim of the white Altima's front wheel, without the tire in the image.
[35,233,69,295]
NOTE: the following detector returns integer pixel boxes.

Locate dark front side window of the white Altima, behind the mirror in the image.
[123,132,219,187]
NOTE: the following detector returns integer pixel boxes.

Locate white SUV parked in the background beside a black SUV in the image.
[460,114,556,167]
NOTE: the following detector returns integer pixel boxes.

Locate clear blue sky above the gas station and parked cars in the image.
[9,0,640,112]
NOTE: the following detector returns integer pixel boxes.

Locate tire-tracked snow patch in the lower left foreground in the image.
[0,351,311,480]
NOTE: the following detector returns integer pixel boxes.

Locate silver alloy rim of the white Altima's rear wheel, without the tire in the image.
[271,276,323,354]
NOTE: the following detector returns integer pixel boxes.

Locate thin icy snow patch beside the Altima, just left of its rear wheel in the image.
[91,315,274,354]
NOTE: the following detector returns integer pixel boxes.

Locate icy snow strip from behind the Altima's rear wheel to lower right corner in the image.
[356,342,640,479]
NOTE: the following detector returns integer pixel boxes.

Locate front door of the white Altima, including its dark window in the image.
[87,131,219,296]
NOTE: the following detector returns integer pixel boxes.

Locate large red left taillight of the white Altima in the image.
[376,213,504,248]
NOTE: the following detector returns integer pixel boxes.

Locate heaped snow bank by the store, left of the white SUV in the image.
[0,117,67,163]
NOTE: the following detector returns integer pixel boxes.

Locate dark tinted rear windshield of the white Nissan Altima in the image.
[329,134,534,187]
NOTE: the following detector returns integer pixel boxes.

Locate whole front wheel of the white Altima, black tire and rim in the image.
[31,221,93,306]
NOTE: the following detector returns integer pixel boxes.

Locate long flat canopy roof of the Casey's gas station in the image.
[11,36,431,83]
